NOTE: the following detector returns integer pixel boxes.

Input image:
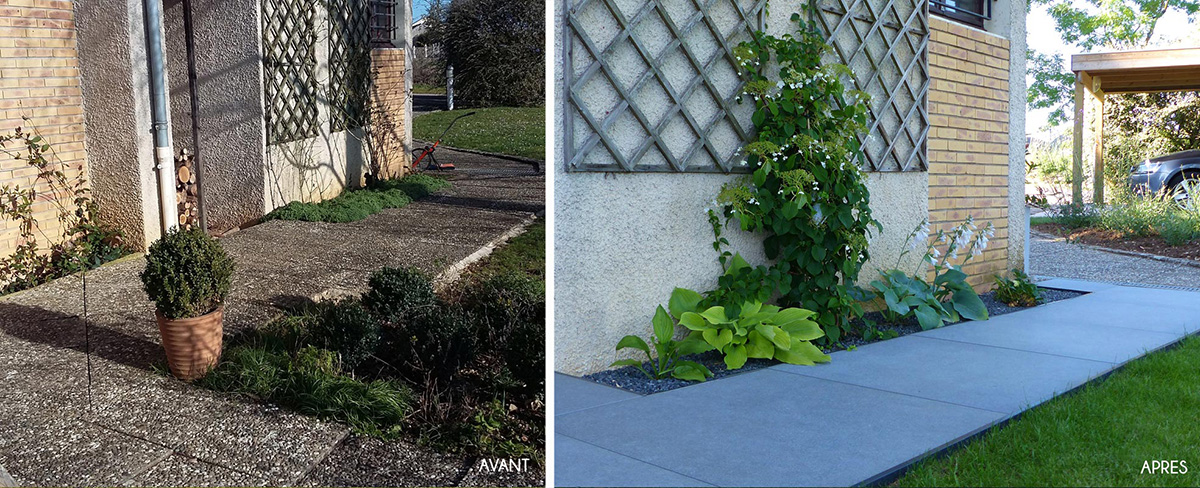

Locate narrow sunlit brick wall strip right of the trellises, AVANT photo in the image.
[371,48,410,177]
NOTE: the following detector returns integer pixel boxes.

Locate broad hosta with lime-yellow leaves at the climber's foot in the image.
[679,295,829,369]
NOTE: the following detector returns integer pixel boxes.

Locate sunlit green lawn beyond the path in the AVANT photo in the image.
[413,107,546,159]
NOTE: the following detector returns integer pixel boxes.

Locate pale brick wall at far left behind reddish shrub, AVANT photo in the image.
[0,0,85,260]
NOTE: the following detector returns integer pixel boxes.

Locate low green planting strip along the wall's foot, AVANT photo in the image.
[263,173,450,223]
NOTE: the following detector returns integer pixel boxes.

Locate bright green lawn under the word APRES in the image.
[894,337,1200,487]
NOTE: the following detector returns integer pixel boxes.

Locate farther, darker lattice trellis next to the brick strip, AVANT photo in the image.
[326,0,371,132]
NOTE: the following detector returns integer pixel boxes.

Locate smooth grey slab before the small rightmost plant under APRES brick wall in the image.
[918,303,1180,365]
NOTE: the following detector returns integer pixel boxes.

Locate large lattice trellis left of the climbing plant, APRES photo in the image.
[563,0,767,173]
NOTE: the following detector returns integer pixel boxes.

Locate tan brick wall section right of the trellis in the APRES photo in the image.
[929,17,1009,290]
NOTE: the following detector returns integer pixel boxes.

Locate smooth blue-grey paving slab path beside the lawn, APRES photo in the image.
[554,279,1200,486]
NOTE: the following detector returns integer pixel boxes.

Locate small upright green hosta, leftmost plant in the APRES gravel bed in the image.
[610,288,713,381]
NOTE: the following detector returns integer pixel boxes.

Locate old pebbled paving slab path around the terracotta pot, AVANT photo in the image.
[0,156,545,486]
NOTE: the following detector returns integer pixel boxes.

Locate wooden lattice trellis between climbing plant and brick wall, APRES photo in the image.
[816,0,929,171]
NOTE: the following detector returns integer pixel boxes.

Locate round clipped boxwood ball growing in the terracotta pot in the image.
[142,228,233,319]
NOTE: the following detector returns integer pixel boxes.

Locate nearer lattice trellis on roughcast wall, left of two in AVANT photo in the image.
[263,0,319,144]
